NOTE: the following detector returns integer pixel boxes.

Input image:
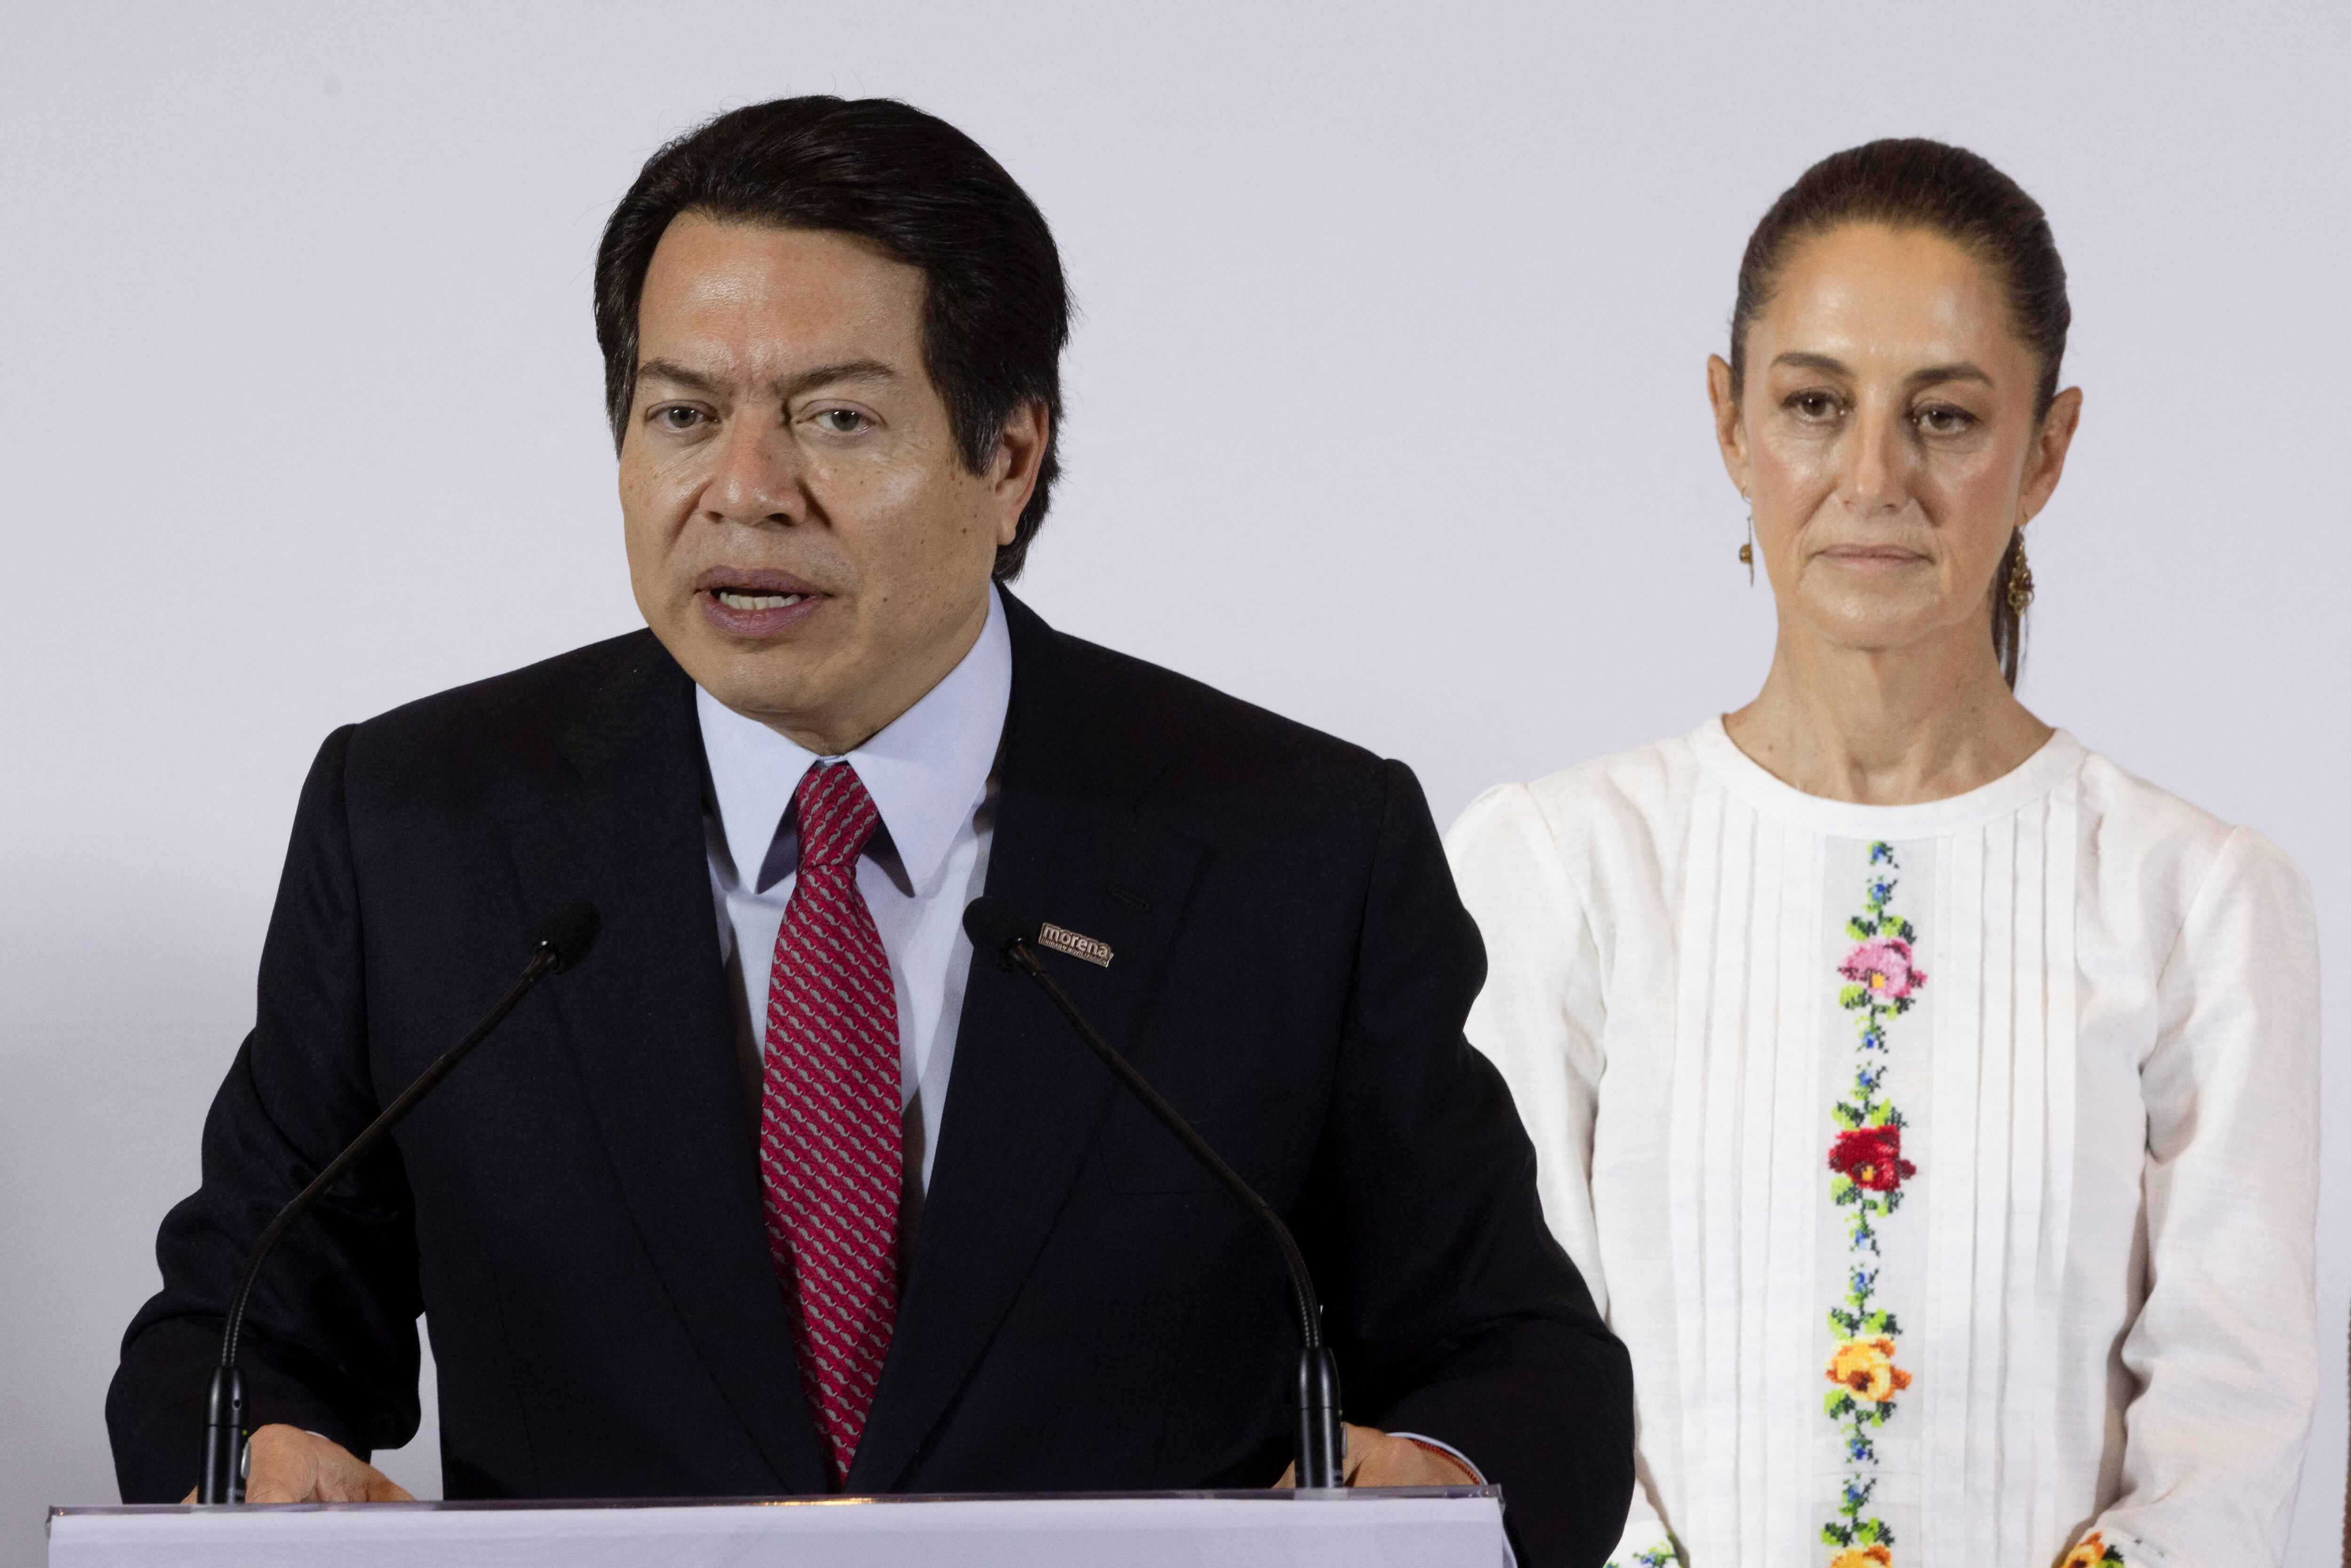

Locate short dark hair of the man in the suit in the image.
[595,96,1070,583]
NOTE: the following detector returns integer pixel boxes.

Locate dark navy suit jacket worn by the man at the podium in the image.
[106,597,1632,1568]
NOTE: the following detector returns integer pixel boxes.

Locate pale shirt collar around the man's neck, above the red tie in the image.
[694,583,1013,893]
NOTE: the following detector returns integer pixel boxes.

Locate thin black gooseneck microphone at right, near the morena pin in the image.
[964,896,1347,1488]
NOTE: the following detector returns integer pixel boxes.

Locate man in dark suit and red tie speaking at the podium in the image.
[108,99,1632,1563]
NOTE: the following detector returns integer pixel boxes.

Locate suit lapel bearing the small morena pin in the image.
[849,595,1199,1490]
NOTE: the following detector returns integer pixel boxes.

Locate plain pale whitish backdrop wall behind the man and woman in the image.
[0,0,2351,1568]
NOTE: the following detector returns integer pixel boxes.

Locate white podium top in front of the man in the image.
[49,1486,1505,1568]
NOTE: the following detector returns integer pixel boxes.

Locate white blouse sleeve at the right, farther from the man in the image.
[2074,827,2318,1568]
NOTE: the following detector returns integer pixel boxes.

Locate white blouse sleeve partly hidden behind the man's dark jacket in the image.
[1446,785,1676,1568]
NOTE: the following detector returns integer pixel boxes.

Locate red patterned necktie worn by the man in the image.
[759,762,900,1486]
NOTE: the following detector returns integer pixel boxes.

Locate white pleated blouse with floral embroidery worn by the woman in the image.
[1448,722,2318,1568]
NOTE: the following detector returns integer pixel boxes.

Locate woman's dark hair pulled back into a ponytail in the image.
[1730,136,2074,686]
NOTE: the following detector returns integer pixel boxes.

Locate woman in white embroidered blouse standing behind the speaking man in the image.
[1448,141,2318,1568]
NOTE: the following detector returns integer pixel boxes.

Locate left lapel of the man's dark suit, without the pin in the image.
[513,635,825,1493]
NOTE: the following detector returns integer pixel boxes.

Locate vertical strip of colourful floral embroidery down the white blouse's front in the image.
[1820,844,1928,1568]
